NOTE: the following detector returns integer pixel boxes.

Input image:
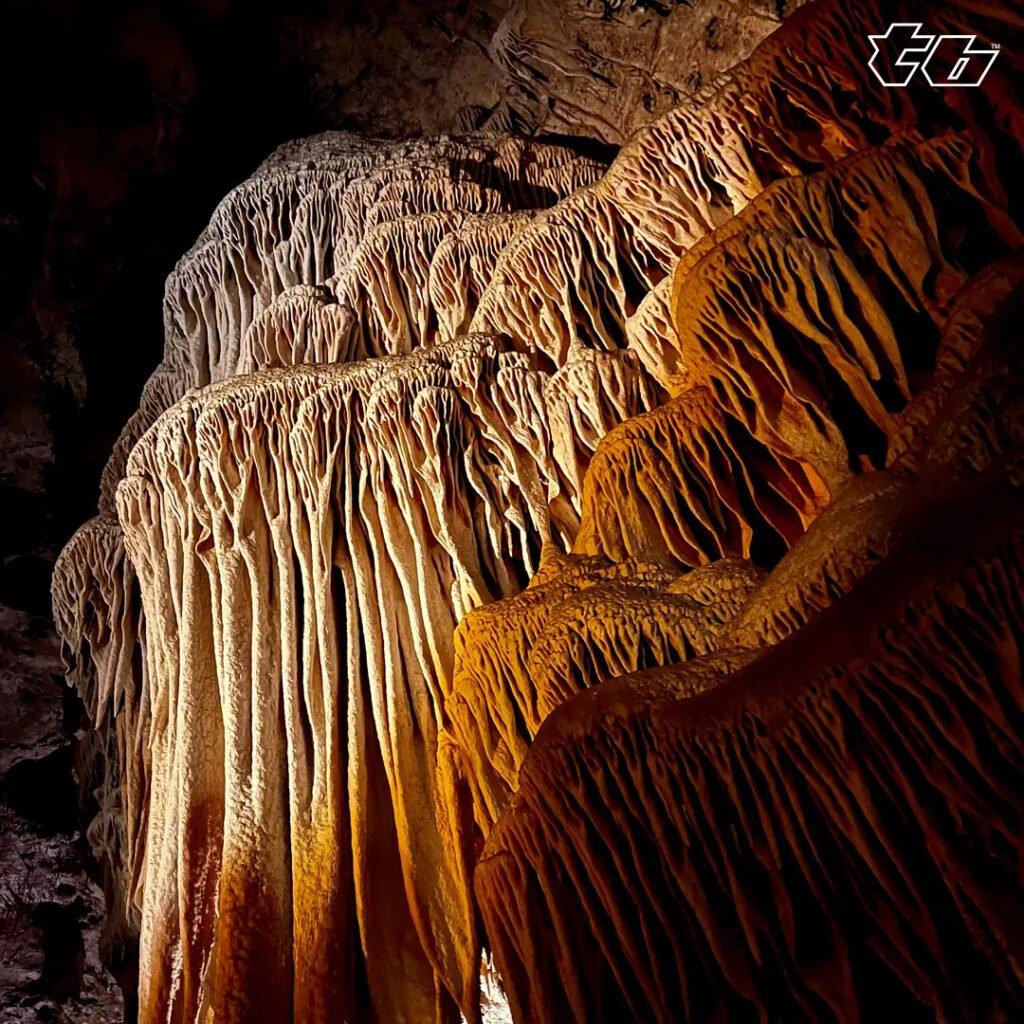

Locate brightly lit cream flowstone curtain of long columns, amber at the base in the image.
[110,336,646,1021]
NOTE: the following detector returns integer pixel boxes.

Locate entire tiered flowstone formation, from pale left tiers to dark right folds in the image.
[53,0,1024,1024]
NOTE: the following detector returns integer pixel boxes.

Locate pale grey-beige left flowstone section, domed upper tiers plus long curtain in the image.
[54,135,638,1021]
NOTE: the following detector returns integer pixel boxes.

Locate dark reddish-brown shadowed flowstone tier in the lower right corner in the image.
[476,307,1024,1021]
